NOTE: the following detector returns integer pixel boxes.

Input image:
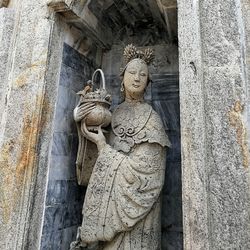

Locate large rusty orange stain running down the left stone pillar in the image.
[0,96,50,224]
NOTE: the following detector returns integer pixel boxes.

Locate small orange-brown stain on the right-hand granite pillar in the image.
[228,101,249,167]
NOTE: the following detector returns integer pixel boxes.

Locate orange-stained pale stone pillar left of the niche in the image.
[0,0,65,249]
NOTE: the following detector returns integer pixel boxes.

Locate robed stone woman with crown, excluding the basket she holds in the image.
[71,45,170,250]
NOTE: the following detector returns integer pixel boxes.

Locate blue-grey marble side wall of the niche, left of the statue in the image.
[40,44,94,250]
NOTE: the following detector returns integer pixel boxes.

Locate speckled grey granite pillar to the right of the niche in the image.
[178,0,250,249]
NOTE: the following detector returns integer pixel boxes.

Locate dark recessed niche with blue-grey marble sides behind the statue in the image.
[41,0,183,250]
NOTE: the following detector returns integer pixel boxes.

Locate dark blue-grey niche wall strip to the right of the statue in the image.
[151,74,183,250]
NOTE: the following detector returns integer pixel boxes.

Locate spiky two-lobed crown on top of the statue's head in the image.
[123,44,155,65]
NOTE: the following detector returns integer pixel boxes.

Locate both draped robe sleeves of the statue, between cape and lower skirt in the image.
[81,143,165,242]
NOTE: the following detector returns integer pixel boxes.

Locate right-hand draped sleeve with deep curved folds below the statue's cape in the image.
[114,143,165,230]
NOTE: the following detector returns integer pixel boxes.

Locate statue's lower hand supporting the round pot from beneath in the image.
[82,121,107,152]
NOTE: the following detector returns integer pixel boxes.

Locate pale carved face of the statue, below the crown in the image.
[123,60,148,99]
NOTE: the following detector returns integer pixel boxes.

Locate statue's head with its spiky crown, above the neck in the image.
[121,45,154,99]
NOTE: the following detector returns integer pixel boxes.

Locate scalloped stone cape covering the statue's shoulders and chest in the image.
[111,102,171,152]
